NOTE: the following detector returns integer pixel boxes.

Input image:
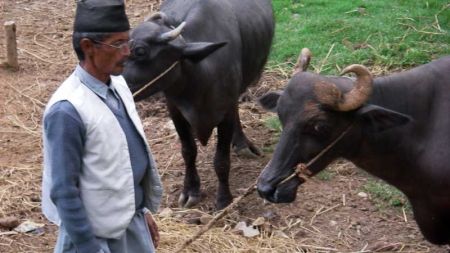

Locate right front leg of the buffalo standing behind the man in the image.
[214,111,234,210]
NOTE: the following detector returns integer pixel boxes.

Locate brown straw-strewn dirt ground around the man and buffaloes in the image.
[0,0,448,253]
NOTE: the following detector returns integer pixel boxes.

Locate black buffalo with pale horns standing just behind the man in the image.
[124,0,274,209]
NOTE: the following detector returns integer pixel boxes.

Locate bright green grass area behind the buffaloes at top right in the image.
[269,0,450,74]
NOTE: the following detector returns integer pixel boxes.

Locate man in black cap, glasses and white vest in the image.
[42,0,162,253]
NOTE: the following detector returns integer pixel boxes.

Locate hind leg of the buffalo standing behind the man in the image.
[232,108,261,157]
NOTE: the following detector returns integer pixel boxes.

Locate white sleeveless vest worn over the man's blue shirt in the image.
[42,74,162,238]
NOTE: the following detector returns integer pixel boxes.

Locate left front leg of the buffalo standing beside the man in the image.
[168,105,201,208]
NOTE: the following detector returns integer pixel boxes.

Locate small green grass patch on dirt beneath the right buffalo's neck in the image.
[362,179,411,210]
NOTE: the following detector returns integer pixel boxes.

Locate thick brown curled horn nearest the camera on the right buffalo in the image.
[336,64,373,111]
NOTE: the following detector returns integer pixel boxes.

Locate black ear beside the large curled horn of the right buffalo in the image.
[356,105,412,133]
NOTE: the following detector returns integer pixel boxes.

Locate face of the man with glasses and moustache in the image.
[92,32,130,75]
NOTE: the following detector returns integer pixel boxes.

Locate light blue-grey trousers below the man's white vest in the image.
[53,211,156,253]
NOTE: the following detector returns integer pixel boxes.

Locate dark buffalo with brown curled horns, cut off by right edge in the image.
[257,49,450,244]
